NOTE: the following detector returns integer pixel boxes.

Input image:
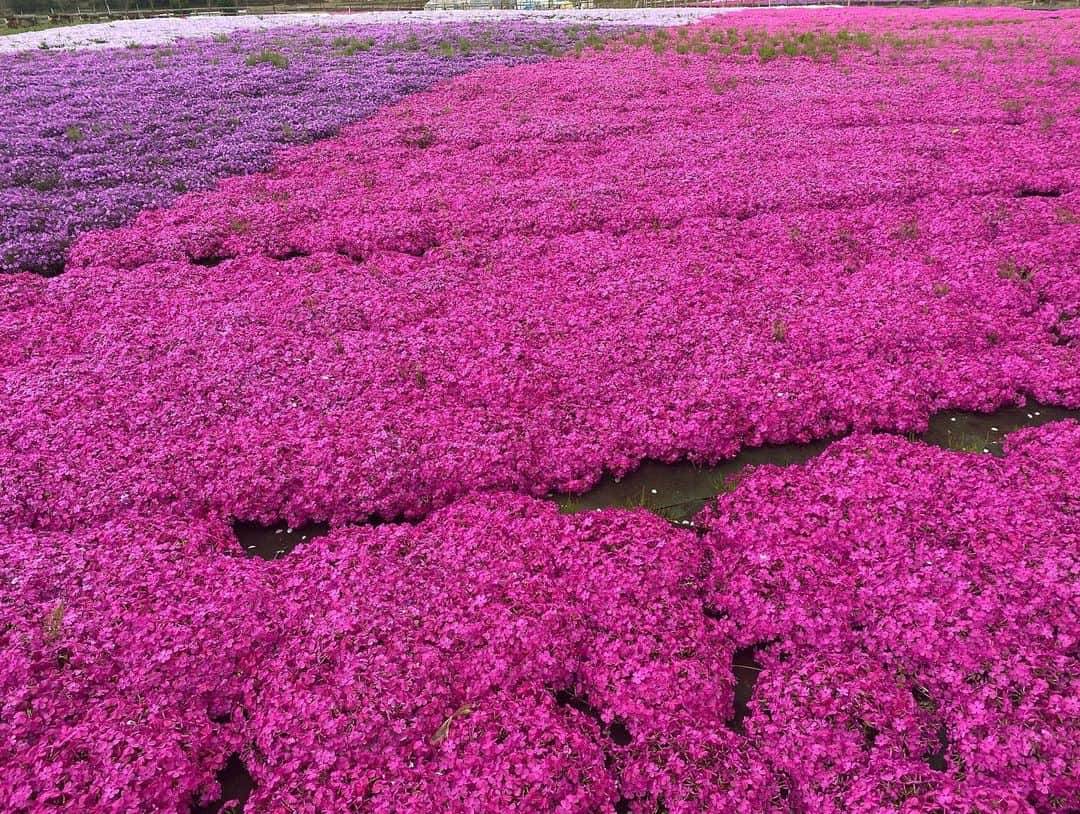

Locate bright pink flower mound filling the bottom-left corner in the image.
[0,519,267,813]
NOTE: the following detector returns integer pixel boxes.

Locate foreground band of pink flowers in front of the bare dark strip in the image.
[0,423,1080,814]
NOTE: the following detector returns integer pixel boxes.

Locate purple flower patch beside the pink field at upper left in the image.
[0,19,622,274]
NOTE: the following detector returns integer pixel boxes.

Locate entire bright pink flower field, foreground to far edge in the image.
[0,9,1080,814]
